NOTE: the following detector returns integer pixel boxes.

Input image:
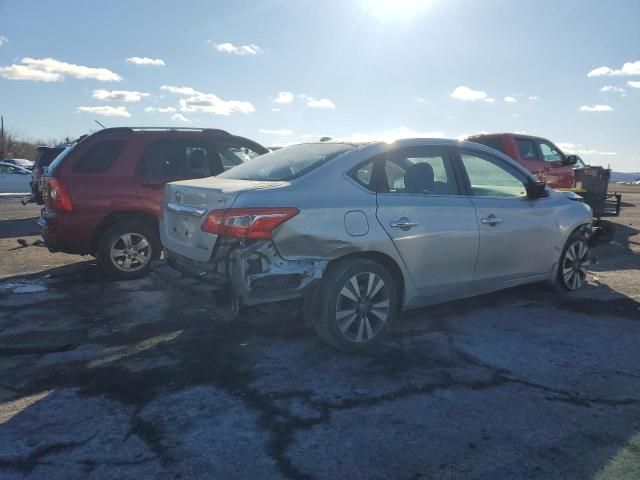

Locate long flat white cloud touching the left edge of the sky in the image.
[0,57,122,82]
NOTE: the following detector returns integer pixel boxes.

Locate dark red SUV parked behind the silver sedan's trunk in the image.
[38,127,268,279]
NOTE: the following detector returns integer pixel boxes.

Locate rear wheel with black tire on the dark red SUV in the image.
[96,220,161,280]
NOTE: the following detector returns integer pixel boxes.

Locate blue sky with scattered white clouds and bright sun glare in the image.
[0,0,640,171]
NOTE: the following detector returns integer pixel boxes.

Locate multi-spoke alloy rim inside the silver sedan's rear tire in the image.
[335,272,389,343]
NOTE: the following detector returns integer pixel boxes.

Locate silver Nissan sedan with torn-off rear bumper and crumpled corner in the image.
[160,139,592,351]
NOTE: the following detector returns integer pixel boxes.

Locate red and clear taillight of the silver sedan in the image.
[201,208,300,239]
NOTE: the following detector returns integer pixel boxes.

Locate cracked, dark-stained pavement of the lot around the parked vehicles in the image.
[0,187,640,480]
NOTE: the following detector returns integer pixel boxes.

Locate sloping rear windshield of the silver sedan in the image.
[218,143,354,181]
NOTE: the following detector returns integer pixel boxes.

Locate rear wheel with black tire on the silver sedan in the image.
[313,259,398,352]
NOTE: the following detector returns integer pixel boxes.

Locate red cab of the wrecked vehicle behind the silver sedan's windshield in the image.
[467,133,578,188]
